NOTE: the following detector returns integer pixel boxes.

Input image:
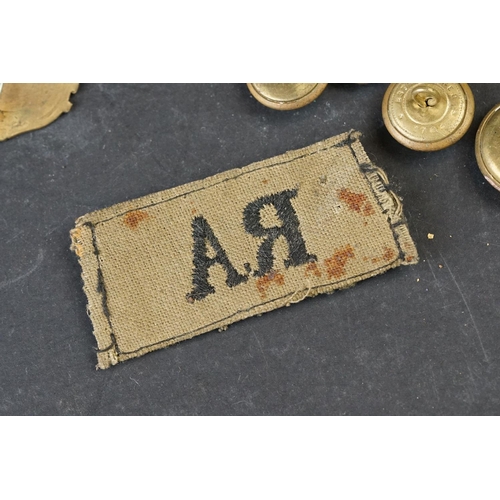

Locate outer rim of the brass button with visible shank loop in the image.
[382,83,475,151]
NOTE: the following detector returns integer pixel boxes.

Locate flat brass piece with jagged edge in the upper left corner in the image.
[0,83,78,141]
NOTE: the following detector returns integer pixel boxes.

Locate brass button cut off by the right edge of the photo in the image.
[476,104,500,191]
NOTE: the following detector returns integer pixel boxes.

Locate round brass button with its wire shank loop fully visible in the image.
[382,83,474,151]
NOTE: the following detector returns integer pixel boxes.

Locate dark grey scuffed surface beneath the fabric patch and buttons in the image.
[0,84,500,415]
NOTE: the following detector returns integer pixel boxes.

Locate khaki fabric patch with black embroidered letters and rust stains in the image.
[71,131,417,368]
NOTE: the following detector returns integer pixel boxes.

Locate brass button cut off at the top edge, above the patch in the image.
[247,83,327,110]
